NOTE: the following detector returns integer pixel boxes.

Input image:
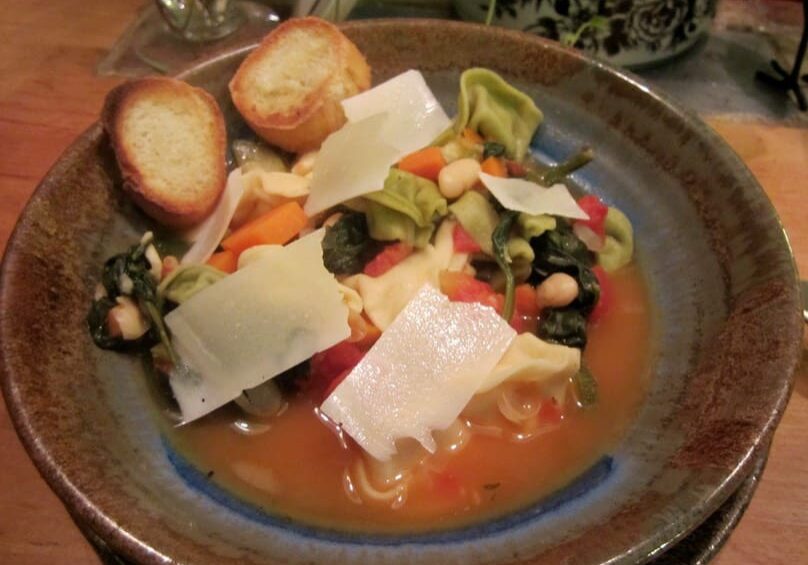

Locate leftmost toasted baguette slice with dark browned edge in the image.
[102,77,227,228]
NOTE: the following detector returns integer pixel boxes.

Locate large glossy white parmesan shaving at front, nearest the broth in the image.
[321,285,516,461]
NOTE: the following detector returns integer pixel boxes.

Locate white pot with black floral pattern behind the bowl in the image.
[454,0,716,68]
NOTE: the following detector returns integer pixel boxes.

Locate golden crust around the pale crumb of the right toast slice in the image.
[229,17,370,153]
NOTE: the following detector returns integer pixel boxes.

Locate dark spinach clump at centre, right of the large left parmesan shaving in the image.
[323,212,384,275]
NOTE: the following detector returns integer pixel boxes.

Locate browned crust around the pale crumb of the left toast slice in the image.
[101,77,227,228]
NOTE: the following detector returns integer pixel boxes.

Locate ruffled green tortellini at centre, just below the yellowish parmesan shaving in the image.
[364,169,448,248]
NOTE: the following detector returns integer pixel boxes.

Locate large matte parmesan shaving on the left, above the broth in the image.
[165,230,351,422]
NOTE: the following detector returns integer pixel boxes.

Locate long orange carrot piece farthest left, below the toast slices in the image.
[222,201,308,256]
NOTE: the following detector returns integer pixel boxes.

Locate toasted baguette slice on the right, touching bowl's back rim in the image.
[230,18,370,153]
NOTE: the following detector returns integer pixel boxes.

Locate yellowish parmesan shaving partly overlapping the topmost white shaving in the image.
[303,114,398,216]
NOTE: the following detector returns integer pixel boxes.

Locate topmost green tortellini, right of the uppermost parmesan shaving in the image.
[453,69,543,161]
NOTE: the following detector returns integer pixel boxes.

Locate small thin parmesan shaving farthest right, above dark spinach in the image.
[480,173,589,220]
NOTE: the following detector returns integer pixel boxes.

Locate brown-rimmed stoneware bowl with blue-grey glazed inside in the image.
[0,20,802,564]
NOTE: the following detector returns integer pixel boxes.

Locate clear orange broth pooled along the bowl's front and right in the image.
[169,266,653,532]
